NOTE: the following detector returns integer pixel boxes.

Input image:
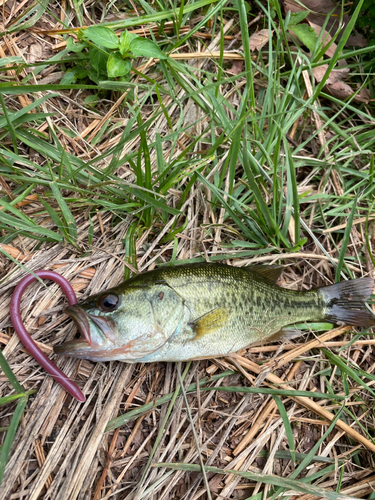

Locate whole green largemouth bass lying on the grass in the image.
[54,263,375,363]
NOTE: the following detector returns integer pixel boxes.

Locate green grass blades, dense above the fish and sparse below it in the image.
[0,0,375,499]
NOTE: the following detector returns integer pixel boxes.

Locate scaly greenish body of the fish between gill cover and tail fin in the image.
[141,266,324,360]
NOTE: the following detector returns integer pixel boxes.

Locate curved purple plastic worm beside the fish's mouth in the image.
[10,271,86,402]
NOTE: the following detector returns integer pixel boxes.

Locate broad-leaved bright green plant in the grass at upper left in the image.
[61,26,167,84]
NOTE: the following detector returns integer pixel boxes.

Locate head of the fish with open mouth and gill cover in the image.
[54,285,189,363]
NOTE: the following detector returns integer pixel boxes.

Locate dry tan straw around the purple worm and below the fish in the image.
[0,228,375,500]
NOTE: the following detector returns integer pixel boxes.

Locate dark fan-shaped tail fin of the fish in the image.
[319,277,375,327]
